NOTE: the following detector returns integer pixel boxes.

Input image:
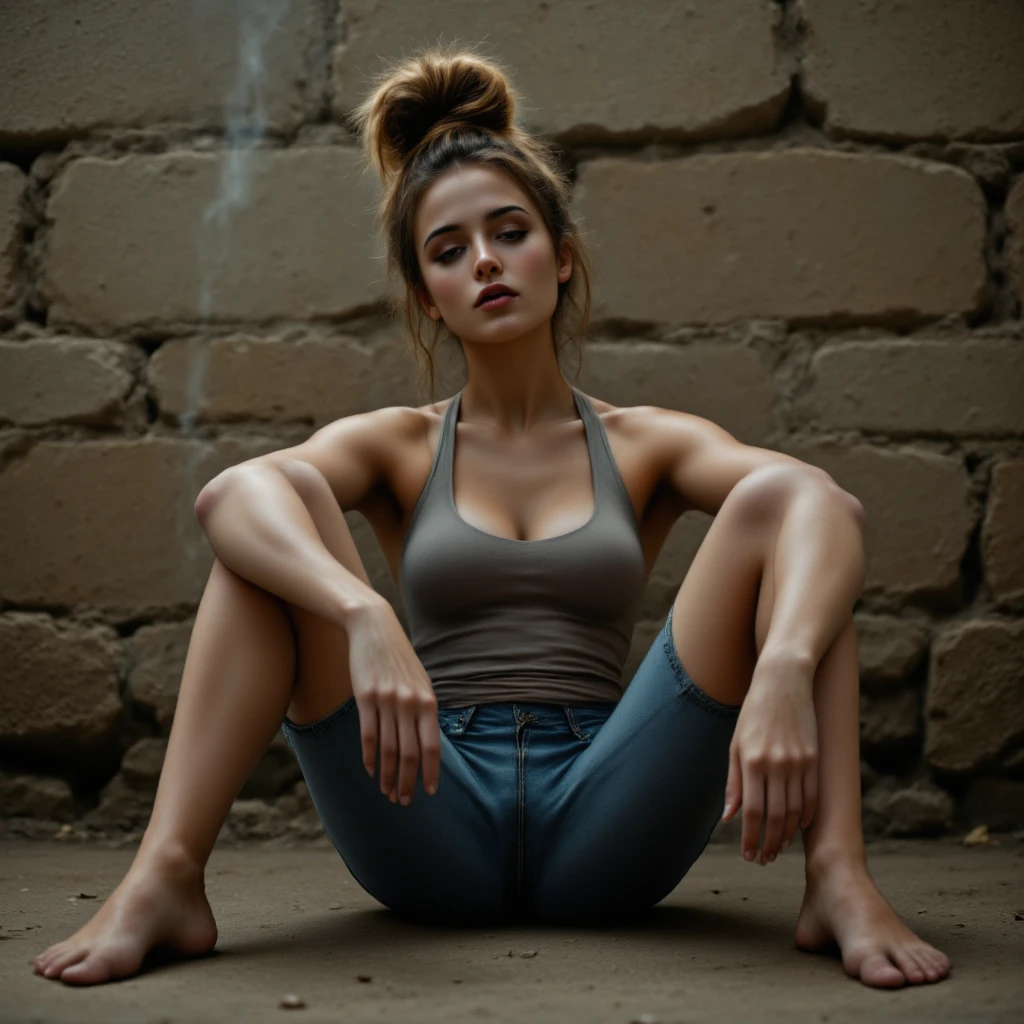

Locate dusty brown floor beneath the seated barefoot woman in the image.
[0,839,1024,1024]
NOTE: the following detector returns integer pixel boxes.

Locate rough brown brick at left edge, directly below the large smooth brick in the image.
[0,612,121,754]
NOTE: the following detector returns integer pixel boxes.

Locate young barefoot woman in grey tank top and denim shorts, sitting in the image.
[34,48,949,987]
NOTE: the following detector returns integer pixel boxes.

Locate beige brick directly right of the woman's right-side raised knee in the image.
[785,441,974,598]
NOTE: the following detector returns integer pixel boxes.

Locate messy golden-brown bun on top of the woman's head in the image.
[348,44,516,178]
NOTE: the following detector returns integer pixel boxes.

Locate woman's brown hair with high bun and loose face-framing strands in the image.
[347,43,591,401]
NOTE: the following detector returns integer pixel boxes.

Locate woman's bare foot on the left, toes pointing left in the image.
[32,852,217,985]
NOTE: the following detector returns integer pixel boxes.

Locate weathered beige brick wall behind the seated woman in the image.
[0,0,1024,836]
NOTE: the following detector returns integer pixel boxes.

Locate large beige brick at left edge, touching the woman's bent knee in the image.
[0,437,282,614]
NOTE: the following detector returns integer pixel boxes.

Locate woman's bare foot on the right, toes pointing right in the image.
[797,862,950,988]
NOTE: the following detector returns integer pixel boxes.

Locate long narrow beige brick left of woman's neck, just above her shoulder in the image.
[147,334,420,423]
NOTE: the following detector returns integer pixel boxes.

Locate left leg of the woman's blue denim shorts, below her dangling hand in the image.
[284,697,509,921]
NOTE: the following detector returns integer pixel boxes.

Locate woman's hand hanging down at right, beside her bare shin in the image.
[722,657,818,864]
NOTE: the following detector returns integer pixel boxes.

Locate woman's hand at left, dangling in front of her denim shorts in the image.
[346,601,441,804]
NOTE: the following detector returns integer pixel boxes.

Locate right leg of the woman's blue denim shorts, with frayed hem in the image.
[526,611,740,921]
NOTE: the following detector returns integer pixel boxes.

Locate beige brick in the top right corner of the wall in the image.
[801,0,1024,141]
